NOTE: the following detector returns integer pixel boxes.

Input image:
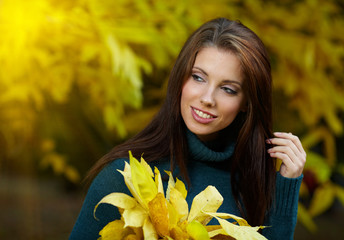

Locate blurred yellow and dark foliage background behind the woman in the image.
[0,0,344,240]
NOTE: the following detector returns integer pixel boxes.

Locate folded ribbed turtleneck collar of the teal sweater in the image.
[186,130,235,162]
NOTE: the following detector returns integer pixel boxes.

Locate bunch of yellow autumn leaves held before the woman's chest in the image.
[94,152,266,240]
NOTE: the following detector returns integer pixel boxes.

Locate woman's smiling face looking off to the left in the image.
[181,47,246,141]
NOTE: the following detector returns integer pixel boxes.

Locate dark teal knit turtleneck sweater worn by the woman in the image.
[70,131,302,240]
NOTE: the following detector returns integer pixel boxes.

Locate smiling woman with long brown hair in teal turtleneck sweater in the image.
[70,18,306,239]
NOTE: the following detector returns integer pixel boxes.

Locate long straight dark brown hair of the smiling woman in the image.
[88,18,276,225]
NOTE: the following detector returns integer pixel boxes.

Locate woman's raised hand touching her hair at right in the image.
[266,132,306,178]
